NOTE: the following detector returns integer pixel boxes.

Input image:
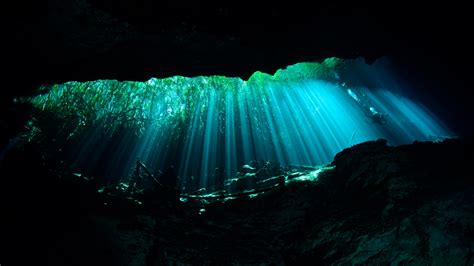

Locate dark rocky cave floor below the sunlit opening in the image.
[0,139,474,265]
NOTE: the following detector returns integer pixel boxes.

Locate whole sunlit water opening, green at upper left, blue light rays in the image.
[25,59,452,190]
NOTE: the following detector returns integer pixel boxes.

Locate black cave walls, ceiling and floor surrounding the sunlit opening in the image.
[0,0,474,265]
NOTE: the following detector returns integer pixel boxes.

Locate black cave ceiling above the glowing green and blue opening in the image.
[2,0,472,131]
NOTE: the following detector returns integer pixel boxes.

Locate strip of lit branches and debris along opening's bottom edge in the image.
[93,157,334,206]
